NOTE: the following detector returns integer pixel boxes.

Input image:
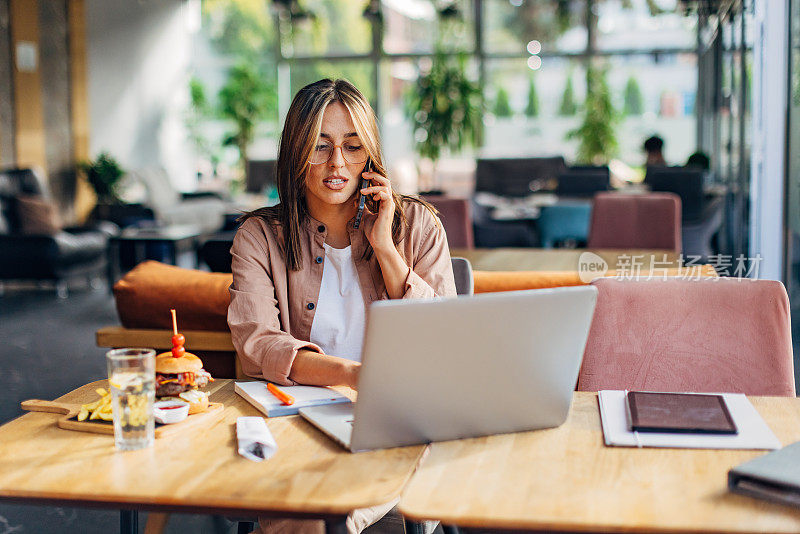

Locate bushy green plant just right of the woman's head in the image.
[406,50,483,161]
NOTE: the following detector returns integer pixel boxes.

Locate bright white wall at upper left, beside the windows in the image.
[86,0,196,190]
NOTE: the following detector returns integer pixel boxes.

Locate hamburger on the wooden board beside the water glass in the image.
[156,352,214,414]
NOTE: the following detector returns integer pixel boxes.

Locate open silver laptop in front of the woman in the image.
[300,286,597,452]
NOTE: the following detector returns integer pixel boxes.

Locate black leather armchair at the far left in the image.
[0,169,117,296]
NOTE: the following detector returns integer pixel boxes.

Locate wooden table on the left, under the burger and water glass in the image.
[0,380,426,532]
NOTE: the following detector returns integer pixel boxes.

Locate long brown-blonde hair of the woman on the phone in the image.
[239,78,436,271]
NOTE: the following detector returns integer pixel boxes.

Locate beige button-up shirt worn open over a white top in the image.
[228,202,456,385]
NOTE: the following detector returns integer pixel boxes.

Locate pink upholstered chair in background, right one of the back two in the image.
[588,193,681,252]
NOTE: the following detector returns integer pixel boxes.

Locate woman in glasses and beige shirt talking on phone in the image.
[228,79,456,532]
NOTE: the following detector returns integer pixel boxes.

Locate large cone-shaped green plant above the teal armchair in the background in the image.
[567,65,619,164]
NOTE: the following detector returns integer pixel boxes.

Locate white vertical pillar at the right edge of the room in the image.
[750,0,789,280]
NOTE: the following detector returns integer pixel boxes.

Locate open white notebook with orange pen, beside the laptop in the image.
[234,381,350,417]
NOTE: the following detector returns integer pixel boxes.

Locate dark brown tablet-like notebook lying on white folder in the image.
[626,391,737,434]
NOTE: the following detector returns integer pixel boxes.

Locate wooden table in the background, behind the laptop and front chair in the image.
[450,248,680,275]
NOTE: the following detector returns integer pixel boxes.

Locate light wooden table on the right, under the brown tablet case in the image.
[400,392,800,533]
